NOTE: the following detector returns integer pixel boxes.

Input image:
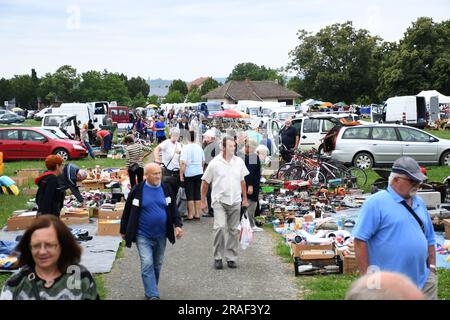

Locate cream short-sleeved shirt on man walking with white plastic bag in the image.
[202,153,250,205]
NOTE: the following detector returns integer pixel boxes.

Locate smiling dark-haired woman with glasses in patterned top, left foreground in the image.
[0,215,99,300]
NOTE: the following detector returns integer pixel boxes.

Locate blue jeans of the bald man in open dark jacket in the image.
[136,236,166,298]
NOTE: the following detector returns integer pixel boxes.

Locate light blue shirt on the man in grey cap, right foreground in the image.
[352,186,436,289]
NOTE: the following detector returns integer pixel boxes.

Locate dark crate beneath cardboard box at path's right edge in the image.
[294,255,343,276]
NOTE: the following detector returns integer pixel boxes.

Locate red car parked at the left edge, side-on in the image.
[0,127,87,160]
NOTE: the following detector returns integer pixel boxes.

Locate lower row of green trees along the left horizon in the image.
[0,65,155,108]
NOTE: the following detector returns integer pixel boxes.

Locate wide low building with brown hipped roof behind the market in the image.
[202,79,300,106]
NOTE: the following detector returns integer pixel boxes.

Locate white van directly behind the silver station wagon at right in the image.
[383,96,427,129]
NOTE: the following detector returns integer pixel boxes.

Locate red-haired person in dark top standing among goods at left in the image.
[34,154,64,217]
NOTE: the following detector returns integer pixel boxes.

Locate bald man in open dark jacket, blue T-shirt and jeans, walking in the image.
[120,163,183,300]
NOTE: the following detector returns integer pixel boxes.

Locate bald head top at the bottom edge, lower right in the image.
[346,272,424,300]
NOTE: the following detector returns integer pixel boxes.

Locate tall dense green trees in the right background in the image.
[287,17,450,104]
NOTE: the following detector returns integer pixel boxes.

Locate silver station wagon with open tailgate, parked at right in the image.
[324,124,450,169]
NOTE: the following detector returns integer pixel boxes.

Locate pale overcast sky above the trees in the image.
[0,0,450,81]
